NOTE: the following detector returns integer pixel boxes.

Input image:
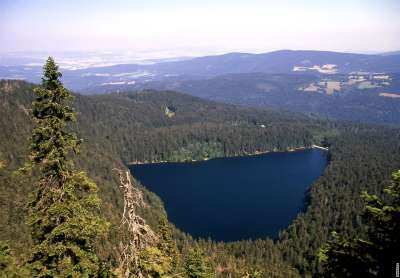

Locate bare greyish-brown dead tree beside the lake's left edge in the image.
[113,169,158,278]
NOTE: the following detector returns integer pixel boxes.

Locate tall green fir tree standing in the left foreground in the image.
[28,57,108,277]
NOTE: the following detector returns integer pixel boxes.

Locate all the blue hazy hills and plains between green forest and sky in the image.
[0,50,400,125]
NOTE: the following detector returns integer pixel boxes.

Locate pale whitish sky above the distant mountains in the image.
[0,0,400,56]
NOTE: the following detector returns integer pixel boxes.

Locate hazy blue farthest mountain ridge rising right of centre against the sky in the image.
[126,50,400,76]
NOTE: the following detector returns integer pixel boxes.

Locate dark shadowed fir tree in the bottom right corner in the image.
[319,171,400,277]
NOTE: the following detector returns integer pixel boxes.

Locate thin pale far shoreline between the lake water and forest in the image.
[127,144,329,166]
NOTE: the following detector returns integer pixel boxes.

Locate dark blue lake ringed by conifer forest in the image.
[131,149,327,241]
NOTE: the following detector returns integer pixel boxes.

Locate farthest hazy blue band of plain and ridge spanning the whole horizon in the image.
[0,50,400,93]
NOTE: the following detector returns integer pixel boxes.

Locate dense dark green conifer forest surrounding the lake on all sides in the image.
[0,64,400,277]
